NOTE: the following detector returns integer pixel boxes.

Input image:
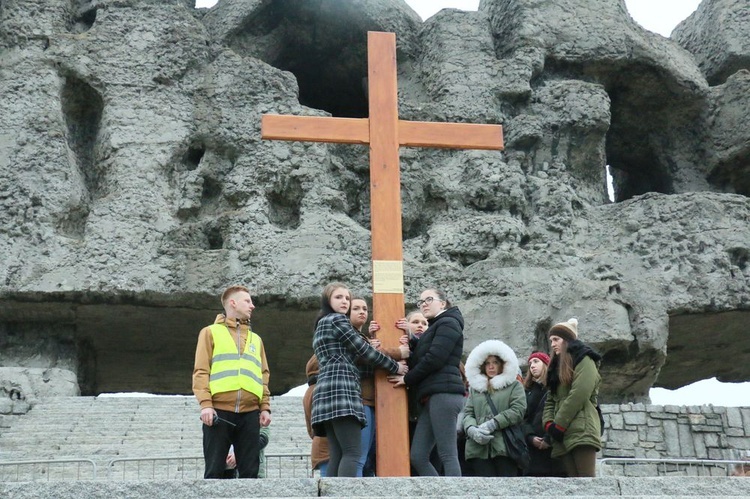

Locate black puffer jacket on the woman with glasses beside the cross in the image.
[404,307,466,401]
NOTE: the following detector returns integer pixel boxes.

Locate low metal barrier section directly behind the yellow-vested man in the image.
[107,453,313,480]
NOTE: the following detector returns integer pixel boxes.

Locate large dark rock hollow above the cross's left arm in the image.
[229,0,376,118]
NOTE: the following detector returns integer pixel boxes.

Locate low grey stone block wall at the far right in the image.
[600,404,750,476]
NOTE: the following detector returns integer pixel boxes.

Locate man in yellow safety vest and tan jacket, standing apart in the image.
[193,286,271,478]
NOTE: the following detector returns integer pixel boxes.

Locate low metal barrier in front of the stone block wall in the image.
[597,457,750,477]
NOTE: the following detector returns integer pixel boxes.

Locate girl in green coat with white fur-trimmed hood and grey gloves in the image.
[463,340,526,476]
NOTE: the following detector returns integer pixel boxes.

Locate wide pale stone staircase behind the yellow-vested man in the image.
[0,396,310,478]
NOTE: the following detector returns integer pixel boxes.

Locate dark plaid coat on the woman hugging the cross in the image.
[312,314,398,437]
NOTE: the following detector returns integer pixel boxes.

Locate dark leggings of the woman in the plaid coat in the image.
[325,416,362,477]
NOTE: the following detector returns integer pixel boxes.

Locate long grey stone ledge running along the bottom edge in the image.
[0,477,750,499]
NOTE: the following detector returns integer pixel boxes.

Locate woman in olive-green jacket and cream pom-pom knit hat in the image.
[543,319,602,477]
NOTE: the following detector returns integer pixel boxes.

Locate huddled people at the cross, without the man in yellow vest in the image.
[303,283,602,477]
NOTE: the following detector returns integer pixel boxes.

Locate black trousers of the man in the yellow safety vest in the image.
[203,410,260,478]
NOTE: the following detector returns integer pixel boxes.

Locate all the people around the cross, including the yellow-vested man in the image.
[193,283,602,478]
